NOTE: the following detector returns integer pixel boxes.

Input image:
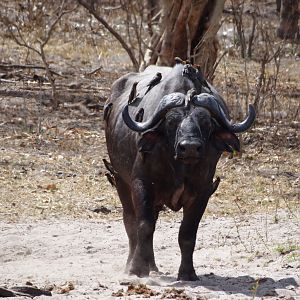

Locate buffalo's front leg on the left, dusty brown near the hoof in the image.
[129,179,157,277]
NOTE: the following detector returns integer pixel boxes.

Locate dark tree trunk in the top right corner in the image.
[277,0,299,39]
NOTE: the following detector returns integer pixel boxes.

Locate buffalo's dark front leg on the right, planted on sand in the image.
[178,198,208,281]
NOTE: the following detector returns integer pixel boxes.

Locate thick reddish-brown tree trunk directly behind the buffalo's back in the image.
[146,0,225,75]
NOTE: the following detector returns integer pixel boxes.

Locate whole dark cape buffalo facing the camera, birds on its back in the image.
[104,64,255,280]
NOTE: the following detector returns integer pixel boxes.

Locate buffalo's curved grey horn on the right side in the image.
[192,93,256,133]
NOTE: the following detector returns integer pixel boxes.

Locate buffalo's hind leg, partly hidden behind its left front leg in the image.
[116,178,137,273]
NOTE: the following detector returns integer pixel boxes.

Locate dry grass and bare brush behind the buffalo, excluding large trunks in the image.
[0,0,300,220]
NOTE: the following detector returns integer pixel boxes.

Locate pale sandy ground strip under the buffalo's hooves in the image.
[0,211,300,300]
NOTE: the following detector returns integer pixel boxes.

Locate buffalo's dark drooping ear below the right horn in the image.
[213,130,240,153]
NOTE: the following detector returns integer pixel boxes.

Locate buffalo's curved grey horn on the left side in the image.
[122,93,185,132]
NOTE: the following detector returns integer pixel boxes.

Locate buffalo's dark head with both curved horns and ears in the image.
[122,90,255,164]
